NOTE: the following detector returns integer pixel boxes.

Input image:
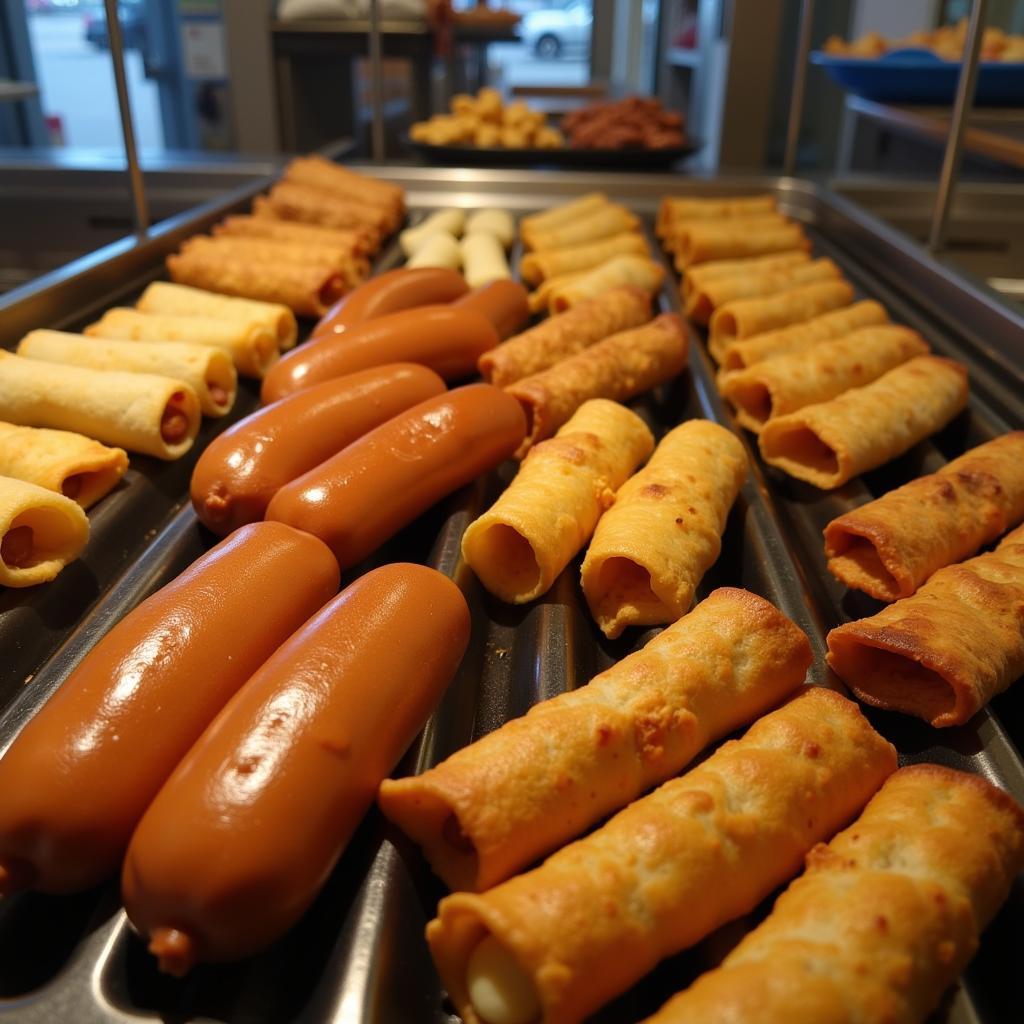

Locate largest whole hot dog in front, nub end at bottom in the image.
[122,564,470,975]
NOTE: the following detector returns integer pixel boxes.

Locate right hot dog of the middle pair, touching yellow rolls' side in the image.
[266,384,526,568]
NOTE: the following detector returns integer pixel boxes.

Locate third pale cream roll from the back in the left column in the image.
[17,331,238,416]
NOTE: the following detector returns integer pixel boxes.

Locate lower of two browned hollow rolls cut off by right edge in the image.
[828,526,1024,728]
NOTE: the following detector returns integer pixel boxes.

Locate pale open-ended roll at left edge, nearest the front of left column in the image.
[0,476,89,587]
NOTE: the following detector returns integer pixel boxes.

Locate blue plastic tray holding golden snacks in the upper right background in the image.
[811,49,1024,105]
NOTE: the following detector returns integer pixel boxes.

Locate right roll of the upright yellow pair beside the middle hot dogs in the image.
[582,420,746,637]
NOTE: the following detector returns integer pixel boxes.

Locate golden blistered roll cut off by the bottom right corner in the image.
[647,764,1024,1024]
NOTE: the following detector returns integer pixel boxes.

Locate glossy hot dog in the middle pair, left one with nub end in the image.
[191,362,444,536]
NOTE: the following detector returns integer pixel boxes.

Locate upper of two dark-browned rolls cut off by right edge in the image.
[824,430,1024,601]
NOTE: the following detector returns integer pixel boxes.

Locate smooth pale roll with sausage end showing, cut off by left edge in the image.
[0,352,200,459]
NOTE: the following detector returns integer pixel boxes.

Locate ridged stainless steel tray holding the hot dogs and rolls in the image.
[0,169,1024,1024]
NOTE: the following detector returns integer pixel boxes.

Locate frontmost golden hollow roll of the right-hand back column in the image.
[758,355,967,490]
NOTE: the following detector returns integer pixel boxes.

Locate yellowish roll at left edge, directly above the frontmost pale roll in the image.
[0,423,128,509]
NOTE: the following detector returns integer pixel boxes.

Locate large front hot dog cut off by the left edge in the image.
[0,522,339,893]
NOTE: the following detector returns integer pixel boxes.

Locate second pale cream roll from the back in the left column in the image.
[85,306,281,377]
